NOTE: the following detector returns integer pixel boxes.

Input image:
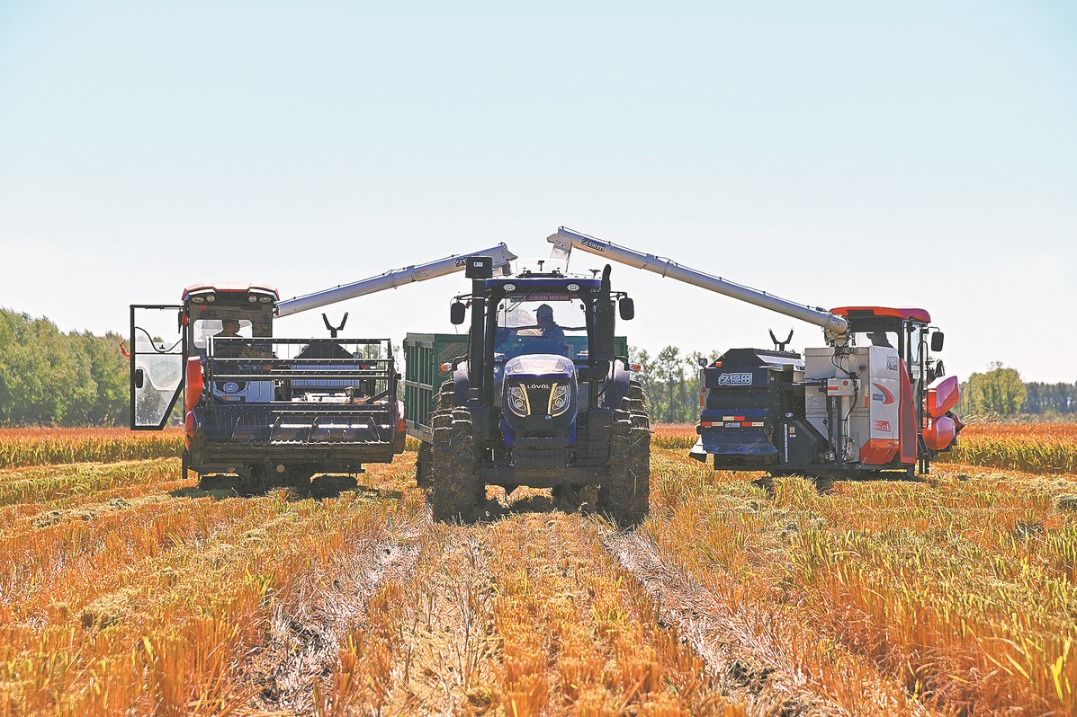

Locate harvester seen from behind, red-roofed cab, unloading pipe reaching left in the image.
[549,227,962,475]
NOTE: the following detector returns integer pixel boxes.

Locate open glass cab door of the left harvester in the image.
[129,305,186,431]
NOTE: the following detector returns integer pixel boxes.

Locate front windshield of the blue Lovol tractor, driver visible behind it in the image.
[493,292,587,359]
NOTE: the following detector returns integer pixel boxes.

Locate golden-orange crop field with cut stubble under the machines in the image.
[0,426,1077,717]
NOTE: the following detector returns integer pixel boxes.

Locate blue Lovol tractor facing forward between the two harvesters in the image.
[405,256,651,523]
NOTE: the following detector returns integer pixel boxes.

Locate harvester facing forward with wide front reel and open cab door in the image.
[130,244,515,490]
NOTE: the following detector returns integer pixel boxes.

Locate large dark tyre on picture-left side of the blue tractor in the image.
[429,408,486,521]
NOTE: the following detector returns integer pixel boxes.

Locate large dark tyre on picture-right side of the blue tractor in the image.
[598,381,651,526]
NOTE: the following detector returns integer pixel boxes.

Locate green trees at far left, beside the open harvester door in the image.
[0,309,128,426]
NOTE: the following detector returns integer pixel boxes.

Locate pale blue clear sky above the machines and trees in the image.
[0,0,1077,381]
